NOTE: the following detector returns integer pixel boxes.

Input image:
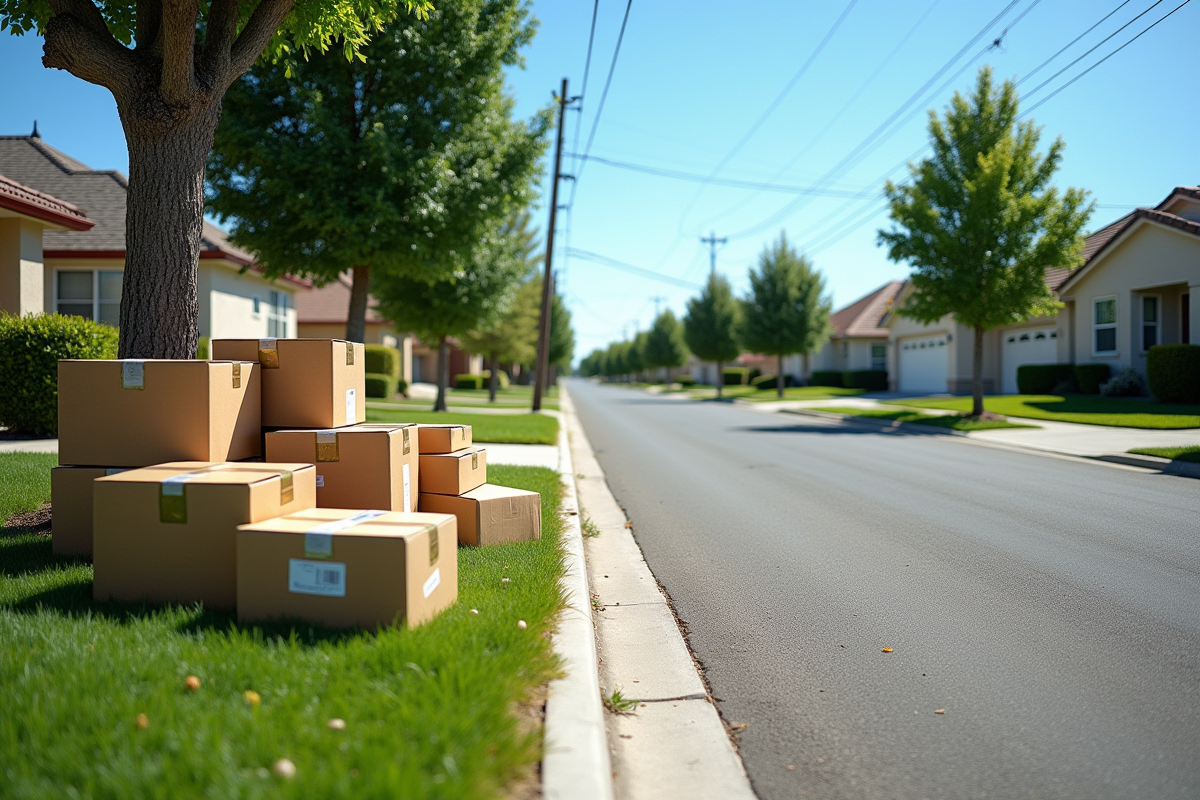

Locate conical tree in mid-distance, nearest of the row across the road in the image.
[740,233,832,399]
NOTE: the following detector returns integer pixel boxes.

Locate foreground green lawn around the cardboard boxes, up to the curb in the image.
[0,455,563,800]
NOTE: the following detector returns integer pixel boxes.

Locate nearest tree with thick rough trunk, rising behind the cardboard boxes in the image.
[0,0,431,359]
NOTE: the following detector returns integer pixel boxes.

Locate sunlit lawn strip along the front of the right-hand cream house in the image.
[883,395,1200,428]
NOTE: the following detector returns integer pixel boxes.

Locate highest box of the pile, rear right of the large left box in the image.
[209,339,367,428]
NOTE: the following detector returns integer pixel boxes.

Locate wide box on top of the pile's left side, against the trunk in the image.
[59,360,262,467]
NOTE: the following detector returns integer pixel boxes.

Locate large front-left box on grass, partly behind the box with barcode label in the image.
[92,462,317,609]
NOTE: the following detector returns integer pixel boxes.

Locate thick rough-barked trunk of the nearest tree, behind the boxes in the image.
[118,102,221,359]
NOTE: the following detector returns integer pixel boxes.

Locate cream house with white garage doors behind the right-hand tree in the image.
[883,186,1200,393]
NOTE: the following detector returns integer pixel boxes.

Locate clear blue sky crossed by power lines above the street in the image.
[0,0,1200,355]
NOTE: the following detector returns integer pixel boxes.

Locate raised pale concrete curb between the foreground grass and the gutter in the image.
[541,407,613,800]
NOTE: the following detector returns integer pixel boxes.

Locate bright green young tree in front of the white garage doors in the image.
[878,67,1093,416]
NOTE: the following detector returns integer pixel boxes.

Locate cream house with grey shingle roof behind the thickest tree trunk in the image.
[0,128,312,338]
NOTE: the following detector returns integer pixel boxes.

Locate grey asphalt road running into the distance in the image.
[570,380,1200,800]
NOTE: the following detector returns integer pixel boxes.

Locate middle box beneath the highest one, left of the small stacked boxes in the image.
[266,423,419,511]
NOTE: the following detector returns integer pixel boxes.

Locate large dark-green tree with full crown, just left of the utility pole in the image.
[209,0,550,342]
